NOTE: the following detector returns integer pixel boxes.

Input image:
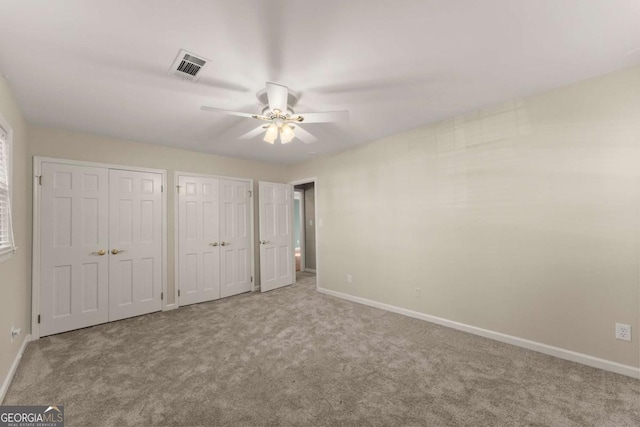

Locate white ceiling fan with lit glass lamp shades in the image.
[201,82,349,144]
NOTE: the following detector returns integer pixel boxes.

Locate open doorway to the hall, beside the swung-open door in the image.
[293,181,316,273]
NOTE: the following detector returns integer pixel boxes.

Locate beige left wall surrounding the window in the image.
[0,75,32,392]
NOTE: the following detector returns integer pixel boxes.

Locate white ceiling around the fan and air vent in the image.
[0,0,640,163]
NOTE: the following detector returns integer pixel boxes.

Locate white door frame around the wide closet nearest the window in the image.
[31,156,168,340]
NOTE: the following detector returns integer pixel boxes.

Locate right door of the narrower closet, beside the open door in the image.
[220,180,251,298]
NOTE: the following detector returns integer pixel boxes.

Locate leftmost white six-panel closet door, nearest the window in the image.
[39,162,109,336]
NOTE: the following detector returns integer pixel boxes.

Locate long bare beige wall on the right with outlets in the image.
[288,67,640,367]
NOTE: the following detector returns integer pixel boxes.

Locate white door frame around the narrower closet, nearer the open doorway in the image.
[172,171,258,308]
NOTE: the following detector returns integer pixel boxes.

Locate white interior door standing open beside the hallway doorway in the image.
[258,181,294,292]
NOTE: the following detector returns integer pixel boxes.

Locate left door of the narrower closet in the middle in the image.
[178,176,220,305]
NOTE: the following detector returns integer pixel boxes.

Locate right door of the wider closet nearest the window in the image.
[109,169,162,320]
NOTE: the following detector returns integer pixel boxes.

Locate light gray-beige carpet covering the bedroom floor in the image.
[4,273,640,426]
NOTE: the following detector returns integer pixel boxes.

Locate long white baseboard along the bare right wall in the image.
[318,288,640,379]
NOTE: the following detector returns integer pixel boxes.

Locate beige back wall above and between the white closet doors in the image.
[29,127,284,303]
